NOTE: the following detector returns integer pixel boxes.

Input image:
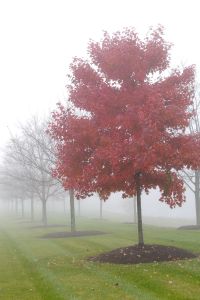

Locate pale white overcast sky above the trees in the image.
[0,0,200,145]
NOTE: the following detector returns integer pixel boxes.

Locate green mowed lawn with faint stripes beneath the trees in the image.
[0,218,200,300]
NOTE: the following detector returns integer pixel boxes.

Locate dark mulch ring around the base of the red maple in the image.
[88,245,197,264]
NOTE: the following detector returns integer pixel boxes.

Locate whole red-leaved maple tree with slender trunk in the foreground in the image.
[49,27,200,245]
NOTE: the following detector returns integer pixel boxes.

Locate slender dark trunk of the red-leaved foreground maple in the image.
[135,173,144,246]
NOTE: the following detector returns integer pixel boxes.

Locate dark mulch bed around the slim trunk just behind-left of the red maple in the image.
[41,230,106,239]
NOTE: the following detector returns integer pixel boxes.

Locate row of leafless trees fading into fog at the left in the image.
[1,117,71,225]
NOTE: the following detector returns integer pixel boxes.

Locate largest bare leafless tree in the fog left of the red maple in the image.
[1,117,64,225]
